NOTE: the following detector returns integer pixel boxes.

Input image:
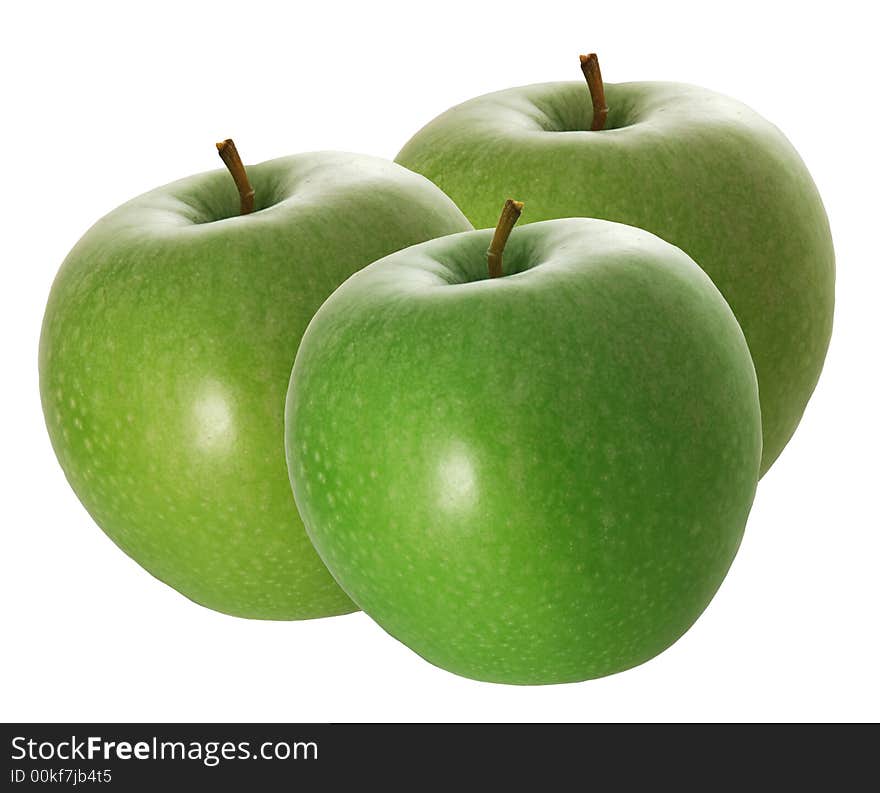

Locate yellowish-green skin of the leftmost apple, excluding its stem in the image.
[40,152,470,619]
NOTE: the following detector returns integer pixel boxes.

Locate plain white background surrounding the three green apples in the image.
[0,0,880,721]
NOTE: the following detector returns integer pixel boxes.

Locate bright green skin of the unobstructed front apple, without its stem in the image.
[285,217,761,684]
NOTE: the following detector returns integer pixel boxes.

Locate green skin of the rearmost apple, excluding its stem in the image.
[397,82,834,473]
